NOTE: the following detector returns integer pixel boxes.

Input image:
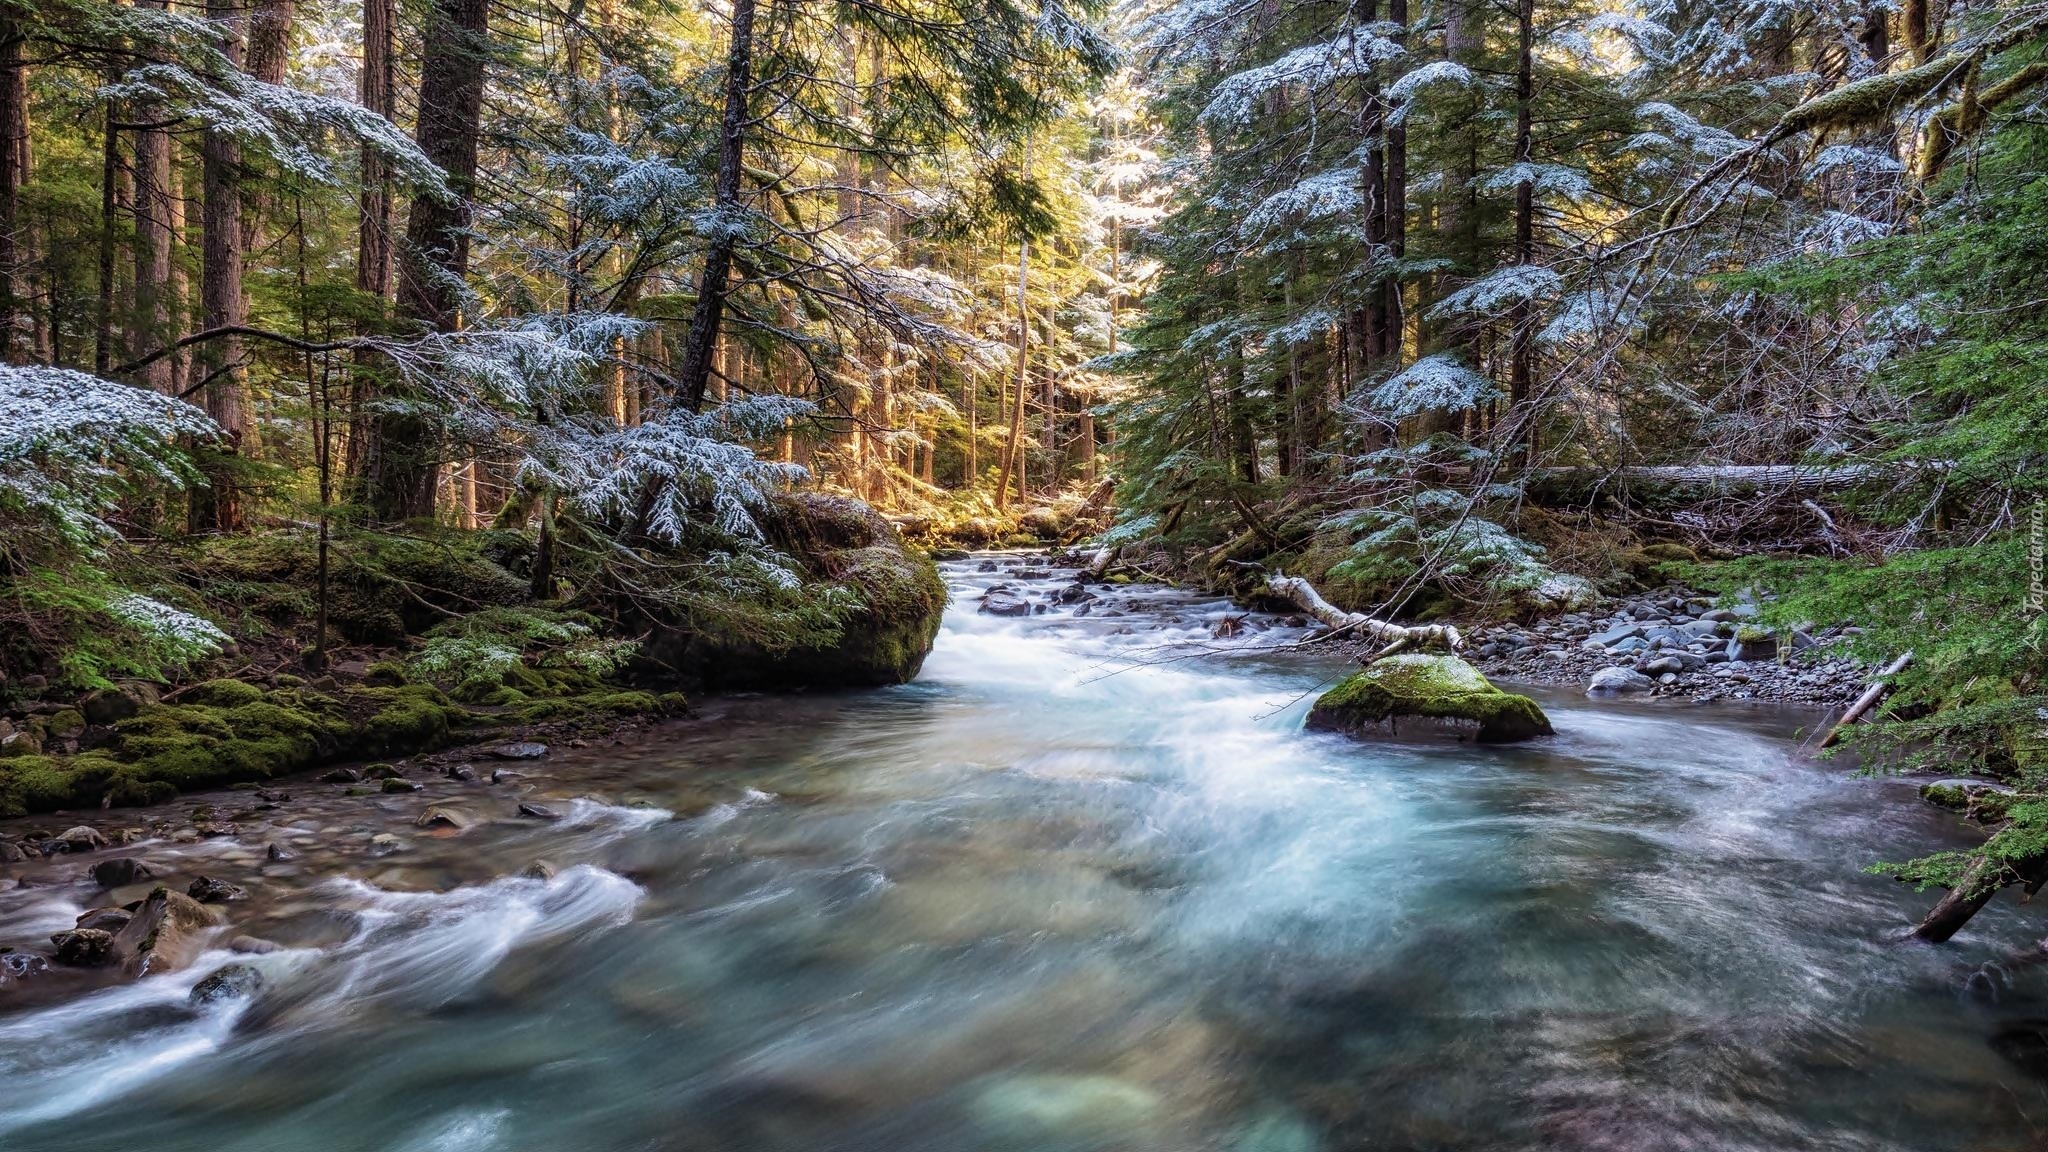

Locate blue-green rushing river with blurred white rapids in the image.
[0,562,2048,1152]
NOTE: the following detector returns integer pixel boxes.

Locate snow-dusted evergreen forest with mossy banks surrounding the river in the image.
[0,0,2048,1150]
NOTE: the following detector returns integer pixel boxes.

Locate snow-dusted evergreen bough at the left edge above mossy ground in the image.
[0,365,219,547]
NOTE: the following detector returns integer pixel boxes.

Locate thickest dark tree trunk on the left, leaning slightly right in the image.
[365,0,489,523]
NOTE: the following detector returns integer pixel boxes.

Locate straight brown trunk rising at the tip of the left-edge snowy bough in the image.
[188,0,248,531]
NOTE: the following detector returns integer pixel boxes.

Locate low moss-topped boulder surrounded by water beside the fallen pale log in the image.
[1309,652,1550,744]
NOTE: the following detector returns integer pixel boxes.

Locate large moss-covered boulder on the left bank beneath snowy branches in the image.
[635,492,946,691]
